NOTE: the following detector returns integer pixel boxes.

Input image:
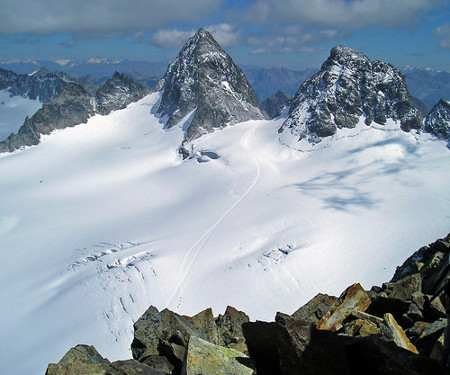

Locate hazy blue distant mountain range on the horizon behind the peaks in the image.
[0,59,450,108]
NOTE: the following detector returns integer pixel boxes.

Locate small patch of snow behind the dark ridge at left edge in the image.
[0,90,42,141]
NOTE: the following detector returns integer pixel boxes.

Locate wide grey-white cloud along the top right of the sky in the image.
[248,0,444,28]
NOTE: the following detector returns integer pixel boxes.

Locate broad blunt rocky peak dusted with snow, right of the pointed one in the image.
[279,46,422,142]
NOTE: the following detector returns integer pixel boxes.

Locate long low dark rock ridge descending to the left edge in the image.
[0,72,148,152]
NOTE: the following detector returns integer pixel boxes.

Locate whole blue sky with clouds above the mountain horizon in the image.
[0,0,450,71]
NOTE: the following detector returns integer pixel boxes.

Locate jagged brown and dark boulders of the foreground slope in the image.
[47,234,450,375]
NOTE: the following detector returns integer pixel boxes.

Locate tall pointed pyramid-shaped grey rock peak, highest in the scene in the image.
[156,29,264,140]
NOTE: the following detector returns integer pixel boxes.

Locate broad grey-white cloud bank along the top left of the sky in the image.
[0,0,221,36]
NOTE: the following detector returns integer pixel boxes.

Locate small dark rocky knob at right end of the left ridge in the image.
[95,72,148,115]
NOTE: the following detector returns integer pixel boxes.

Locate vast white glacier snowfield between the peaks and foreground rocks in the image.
[0,93,450,375]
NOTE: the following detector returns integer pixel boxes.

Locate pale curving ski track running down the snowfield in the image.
[167,124,261,310]
